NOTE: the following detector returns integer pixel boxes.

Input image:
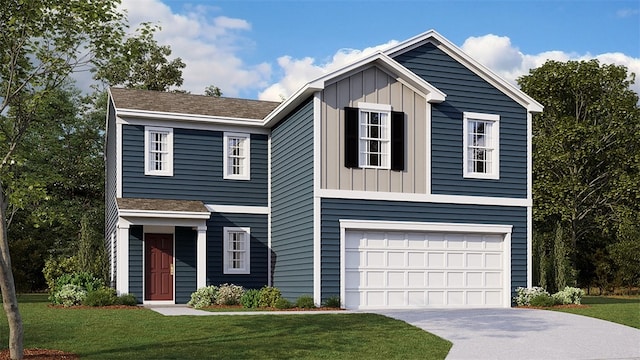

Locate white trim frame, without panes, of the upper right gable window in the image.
[462,112,500,180]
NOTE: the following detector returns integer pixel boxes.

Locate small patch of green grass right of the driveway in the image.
[553,296,640,329]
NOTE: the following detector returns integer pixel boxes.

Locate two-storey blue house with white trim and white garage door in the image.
[105,31,542,309]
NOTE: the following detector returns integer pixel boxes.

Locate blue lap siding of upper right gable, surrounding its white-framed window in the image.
[394,43,527,198]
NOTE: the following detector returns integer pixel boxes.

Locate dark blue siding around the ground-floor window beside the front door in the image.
[206,213,269,289]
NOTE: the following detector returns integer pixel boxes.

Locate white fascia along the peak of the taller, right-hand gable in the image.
[384,30,544,113]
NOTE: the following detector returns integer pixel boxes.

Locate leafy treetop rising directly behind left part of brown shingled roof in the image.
[94,23,186,91]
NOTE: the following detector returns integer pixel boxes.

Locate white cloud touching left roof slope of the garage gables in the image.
[258,40,397,101]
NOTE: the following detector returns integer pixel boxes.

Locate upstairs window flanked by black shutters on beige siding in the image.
[345,103,404,170]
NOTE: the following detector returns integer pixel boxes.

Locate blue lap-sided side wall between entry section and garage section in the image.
[271,99,313,300]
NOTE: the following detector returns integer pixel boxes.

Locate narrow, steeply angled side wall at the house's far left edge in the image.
[104,101,118,281]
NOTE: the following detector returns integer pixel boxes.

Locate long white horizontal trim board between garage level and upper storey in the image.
[317,189,532,207]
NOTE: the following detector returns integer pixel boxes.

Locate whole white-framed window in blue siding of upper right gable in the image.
[463,112,500,179]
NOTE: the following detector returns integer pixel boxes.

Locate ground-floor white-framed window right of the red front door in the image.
[223,227,251,274]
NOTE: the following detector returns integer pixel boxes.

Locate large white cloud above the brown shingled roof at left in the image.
[121,0,271,97]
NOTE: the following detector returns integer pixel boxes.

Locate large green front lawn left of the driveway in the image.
[0,295,451,359]
